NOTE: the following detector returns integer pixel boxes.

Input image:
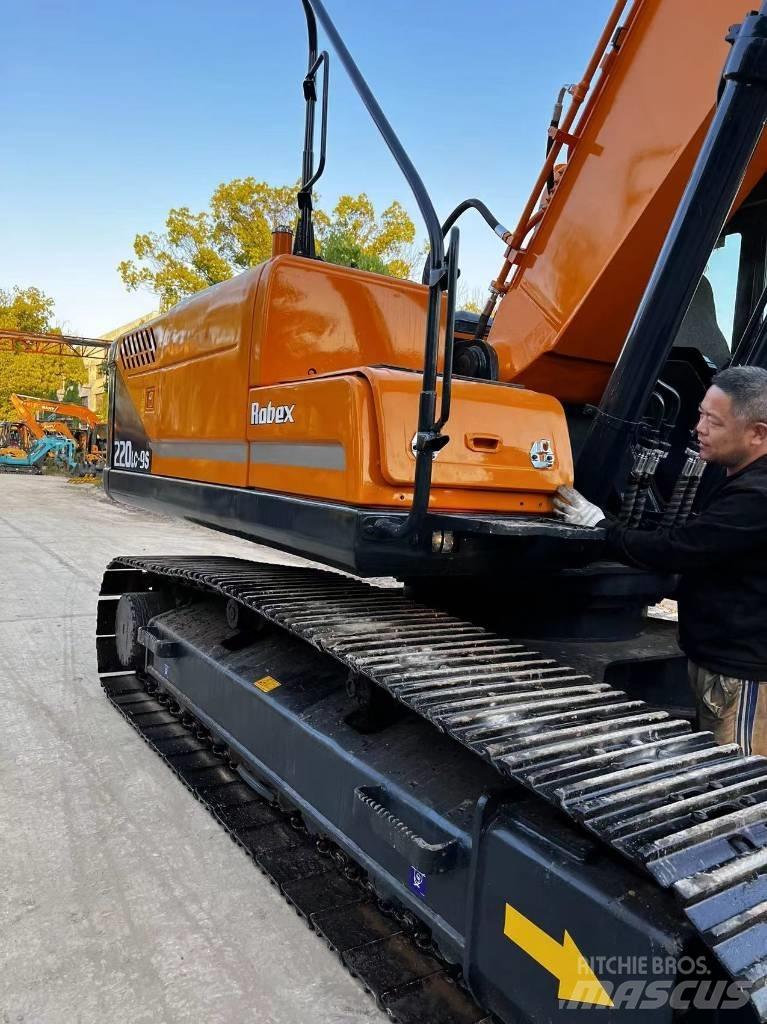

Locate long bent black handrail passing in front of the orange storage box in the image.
[294,0,458,539]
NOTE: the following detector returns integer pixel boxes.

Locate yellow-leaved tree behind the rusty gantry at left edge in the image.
[0,287,88,420]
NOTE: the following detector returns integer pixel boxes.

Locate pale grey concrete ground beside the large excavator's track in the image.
[0,475,383,1024]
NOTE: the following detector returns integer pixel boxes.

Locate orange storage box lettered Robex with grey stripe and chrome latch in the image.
[248,367,572,514]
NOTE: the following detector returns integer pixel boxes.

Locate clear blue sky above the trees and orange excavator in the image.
[0,0,612,336]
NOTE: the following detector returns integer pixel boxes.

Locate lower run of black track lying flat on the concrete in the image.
[101,672,494,1024]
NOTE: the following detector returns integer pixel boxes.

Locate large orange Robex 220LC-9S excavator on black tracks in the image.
[96,0,767,1024]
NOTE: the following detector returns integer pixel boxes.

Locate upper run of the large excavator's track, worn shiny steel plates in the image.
[98,557,767,1021]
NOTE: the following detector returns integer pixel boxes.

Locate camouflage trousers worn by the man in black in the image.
[687,662,767,755]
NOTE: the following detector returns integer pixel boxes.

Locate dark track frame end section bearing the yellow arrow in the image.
[467,809,687,1024]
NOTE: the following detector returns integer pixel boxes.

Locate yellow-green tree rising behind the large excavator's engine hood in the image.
[118,177,417,309]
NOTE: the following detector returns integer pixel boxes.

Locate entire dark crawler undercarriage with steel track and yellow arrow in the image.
[97,557,767,1024]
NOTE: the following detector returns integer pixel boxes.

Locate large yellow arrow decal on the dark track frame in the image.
[504,903,612,1007]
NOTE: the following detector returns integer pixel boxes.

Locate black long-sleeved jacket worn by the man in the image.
[607,456,767,682]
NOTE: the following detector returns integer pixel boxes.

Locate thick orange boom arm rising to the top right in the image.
[489,0,764,401]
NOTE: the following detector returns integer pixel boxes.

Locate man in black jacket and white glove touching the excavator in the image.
[554,367,767,755]
